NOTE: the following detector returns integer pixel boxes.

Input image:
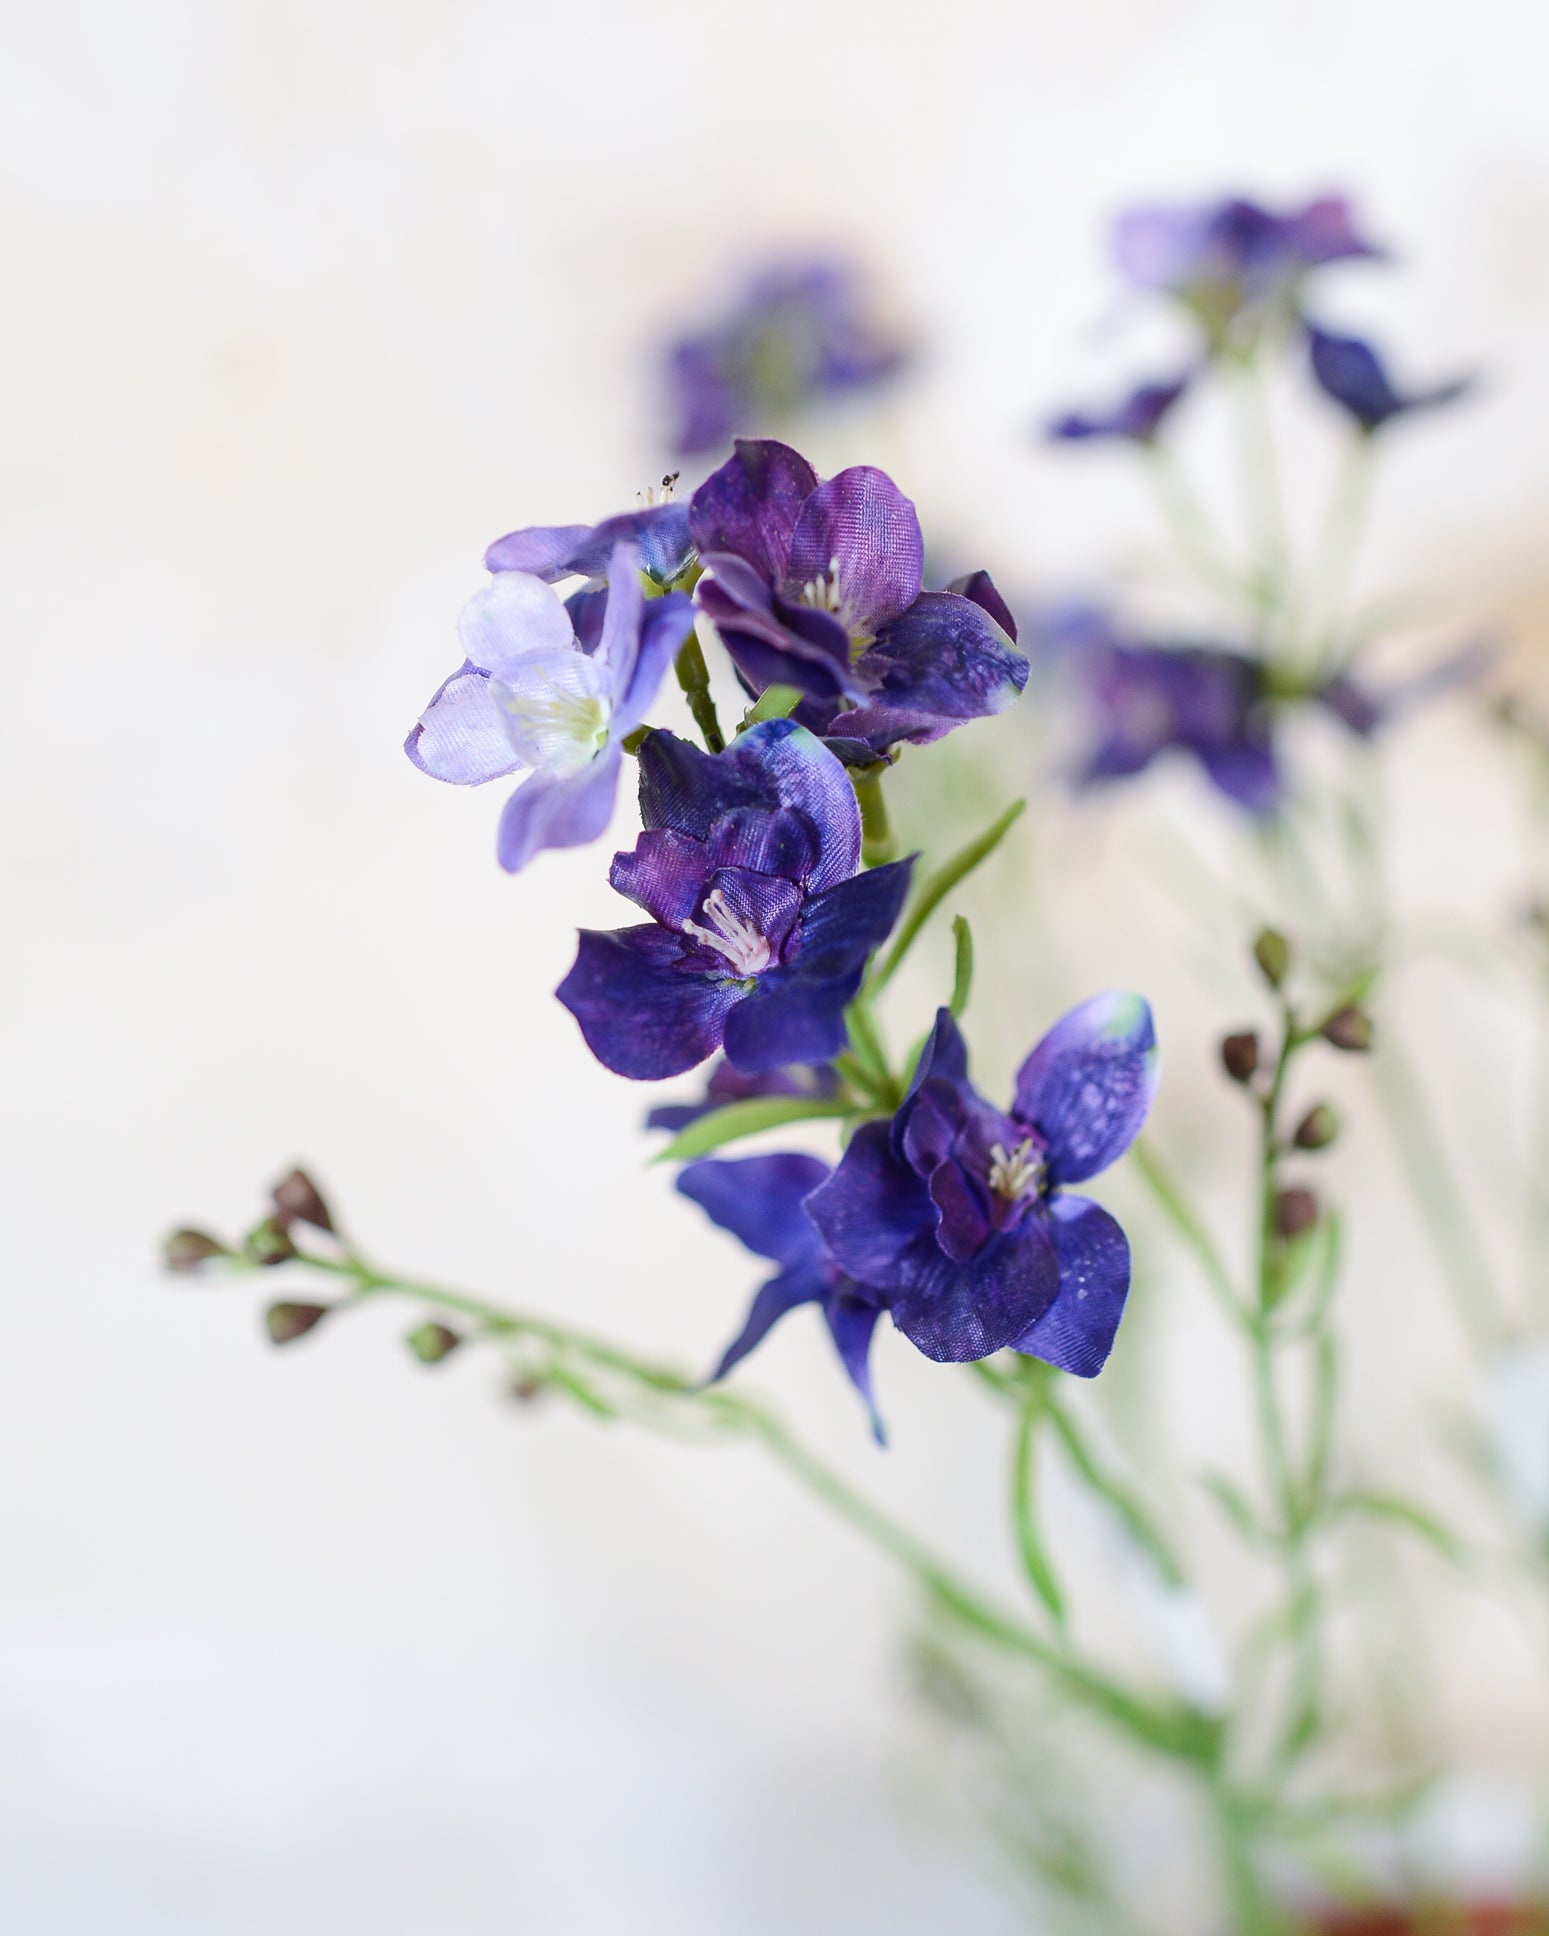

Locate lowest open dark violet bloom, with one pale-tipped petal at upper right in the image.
[807,995,1156,1378]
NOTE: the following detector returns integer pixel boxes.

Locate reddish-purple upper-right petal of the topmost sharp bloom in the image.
[786,465,926,633]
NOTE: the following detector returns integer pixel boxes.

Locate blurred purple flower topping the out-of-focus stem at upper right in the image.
[1113,196,1381,348]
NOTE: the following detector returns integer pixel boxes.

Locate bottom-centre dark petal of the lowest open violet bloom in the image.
[893,1216,1059,1365]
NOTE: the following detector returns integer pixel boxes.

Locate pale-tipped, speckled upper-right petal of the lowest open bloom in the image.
[1015,993,1156,1185]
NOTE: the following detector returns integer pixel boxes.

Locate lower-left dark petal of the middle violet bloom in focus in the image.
[556,922,742,1082]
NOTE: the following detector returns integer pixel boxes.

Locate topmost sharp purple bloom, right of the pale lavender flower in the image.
[689,439,1028,759]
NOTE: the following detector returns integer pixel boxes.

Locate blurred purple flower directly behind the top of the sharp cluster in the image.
[668,261,904,457]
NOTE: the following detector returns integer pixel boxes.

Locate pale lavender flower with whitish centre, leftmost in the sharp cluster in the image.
[403,544,691,873]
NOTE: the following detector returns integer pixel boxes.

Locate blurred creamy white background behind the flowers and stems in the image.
[0,0,1549,1936]
